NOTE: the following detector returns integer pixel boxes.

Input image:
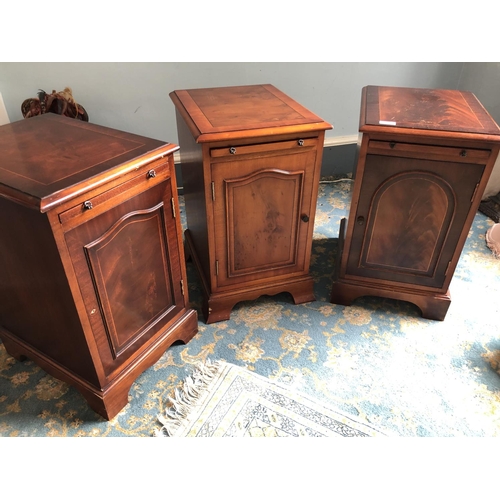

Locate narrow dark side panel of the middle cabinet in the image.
[176,110,210,276]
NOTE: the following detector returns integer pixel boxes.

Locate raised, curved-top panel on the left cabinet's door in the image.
[84,204,173,357]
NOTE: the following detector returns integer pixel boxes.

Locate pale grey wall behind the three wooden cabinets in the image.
[0,62,500,183]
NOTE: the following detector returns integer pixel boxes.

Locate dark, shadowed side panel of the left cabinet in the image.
[0,198,98,384]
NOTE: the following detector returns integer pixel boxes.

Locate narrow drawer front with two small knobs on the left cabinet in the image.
[59,159,170,224]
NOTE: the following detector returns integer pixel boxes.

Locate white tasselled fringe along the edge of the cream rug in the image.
[154,359,223,437]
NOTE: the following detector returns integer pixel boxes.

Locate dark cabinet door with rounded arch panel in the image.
[347,154,484,288]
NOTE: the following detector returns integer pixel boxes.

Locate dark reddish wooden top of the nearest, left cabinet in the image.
[0,113,179,212]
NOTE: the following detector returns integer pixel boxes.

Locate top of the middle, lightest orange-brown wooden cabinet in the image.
[170,84,332,143]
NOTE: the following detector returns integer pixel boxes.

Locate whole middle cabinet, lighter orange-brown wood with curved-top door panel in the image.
[170,85,332,323]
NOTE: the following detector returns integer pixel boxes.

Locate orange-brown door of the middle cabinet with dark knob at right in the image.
[211,147,316,287]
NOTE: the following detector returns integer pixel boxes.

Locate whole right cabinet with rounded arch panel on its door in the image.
[331,86,500,320]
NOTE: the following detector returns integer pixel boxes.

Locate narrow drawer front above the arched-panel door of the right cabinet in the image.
[368,140,491,164]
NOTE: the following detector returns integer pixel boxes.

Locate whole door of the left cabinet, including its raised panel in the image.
[65,179,185,374]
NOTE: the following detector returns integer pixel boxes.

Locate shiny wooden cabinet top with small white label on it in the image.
[360,86,500,141]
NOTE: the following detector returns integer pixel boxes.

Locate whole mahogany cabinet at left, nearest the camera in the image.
[0,113,198,419]
